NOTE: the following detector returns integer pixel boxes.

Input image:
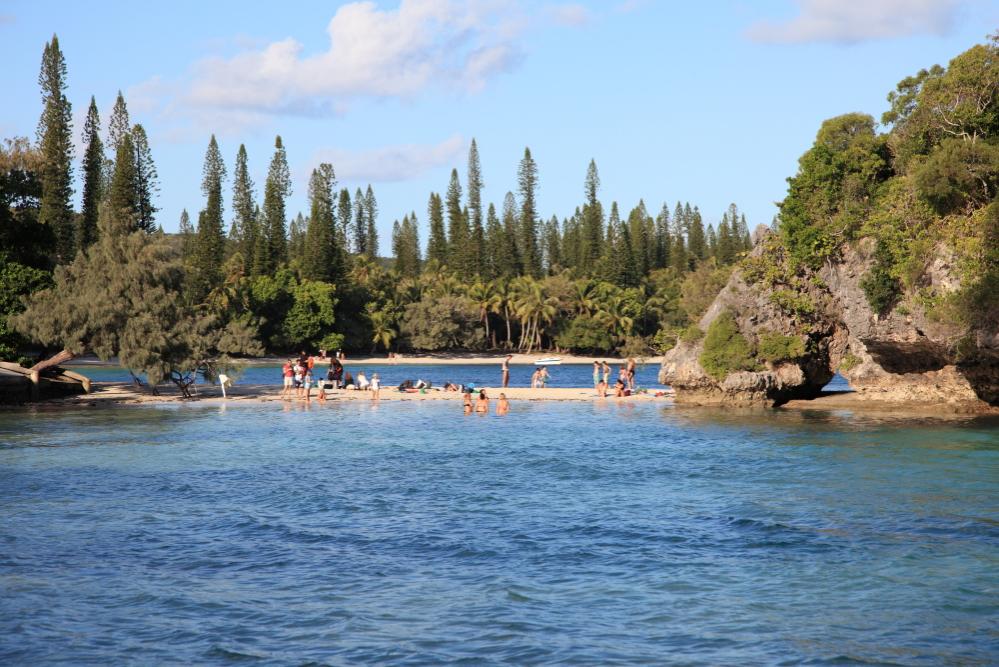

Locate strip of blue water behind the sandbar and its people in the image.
[64,360,849,390]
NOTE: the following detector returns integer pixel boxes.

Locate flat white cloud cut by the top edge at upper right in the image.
[747,0,959,43]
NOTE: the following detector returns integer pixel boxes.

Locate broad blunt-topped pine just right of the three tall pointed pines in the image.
[302,162,340,283]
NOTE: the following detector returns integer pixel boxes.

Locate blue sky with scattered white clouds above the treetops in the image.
[0,0,999,243]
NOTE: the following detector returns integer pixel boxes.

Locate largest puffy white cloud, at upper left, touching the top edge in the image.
[184,0,519,115]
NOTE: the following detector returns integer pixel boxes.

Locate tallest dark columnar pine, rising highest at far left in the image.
[38,35,76,262]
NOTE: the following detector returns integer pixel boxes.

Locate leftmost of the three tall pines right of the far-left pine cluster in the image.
[187,134,226,303]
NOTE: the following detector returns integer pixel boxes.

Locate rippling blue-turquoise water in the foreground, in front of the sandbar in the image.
[0,402,999,665]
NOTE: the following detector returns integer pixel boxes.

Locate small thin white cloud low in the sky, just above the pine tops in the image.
[312,135,468,183]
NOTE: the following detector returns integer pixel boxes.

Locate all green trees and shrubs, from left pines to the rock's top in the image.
[0,32,999,392]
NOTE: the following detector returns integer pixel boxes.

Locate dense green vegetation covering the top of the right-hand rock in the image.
[768,36,999,327]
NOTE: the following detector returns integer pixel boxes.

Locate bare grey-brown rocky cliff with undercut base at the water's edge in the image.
[660,236,999,410]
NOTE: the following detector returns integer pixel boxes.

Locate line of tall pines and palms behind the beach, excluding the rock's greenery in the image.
[0,36,752,392]
